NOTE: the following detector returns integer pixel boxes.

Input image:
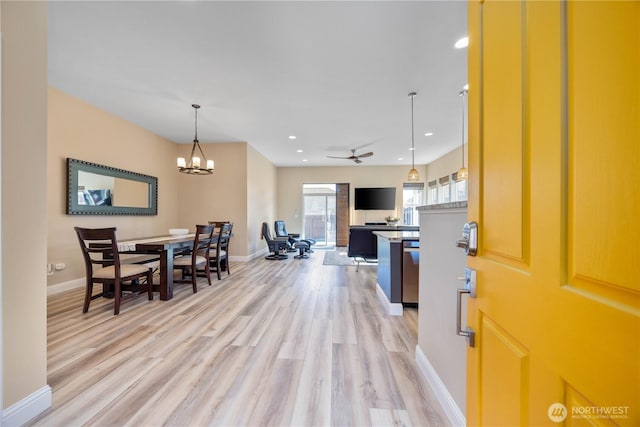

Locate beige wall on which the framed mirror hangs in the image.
[43,87,179,286]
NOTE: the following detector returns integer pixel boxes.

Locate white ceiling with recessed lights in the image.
[48,1,467,166]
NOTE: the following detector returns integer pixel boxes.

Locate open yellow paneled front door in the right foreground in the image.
[466,1,640,426]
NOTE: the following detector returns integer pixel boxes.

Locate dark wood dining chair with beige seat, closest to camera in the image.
[74,227,153,315]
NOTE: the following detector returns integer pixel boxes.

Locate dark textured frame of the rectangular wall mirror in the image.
[67,157,158,215]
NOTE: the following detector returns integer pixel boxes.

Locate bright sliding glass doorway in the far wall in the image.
[302,184,336,248]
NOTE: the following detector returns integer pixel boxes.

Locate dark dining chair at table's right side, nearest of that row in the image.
[173,224,214,294]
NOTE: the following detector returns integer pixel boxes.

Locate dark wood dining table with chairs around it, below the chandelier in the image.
[118,234,217,301]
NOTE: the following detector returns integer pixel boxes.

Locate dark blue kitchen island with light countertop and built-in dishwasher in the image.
[373,231,420,316]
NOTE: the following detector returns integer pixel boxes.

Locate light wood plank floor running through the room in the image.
[30,250,447,426]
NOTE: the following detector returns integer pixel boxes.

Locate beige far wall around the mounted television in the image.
[270,165,426,233]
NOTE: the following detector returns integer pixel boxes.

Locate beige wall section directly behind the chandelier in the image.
[172,142,249,258]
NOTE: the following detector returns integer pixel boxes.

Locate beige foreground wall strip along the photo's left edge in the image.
[0,1,47,408]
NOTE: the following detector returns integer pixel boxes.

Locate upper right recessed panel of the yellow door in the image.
[567,3,640,301]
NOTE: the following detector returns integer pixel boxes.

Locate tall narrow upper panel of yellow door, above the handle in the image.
[482,2,526,261]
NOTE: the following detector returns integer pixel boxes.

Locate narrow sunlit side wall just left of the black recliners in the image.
[247,146,278,256]
